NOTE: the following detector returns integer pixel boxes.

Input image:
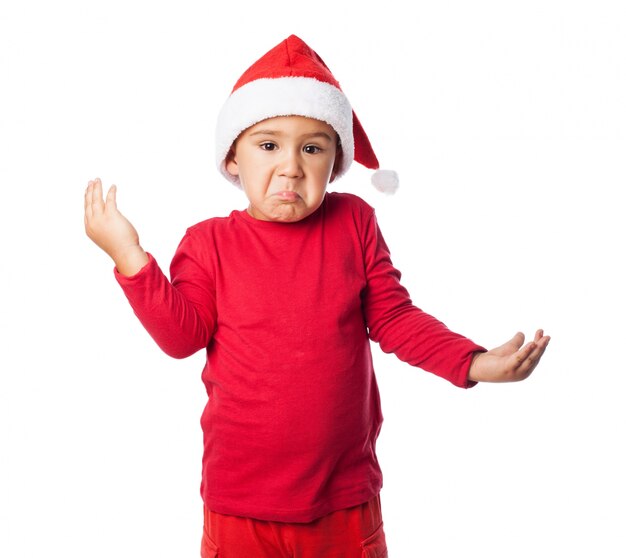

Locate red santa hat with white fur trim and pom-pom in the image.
[216,35,398,193]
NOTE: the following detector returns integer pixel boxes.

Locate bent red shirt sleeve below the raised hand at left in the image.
[115,233,216,358]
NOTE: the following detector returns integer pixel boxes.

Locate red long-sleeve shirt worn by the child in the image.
[116,193,484,522]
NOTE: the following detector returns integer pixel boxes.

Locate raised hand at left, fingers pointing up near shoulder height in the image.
[85,178,148,276]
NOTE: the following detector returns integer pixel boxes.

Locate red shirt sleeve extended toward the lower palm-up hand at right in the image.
[363,213,485,388]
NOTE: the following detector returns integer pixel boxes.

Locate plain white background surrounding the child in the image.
[0,0,626,558]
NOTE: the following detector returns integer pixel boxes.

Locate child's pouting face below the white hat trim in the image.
[226,116,338,222]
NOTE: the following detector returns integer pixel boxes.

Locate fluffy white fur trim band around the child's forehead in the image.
[216,77,354,186]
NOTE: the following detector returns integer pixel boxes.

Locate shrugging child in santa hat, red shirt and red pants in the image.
[85,36,549,558]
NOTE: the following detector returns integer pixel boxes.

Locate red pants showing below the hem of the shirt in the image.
[201,496,387,558]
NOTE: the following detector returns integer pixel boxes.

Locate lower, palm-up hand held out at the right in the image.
[468,329,550,382]
